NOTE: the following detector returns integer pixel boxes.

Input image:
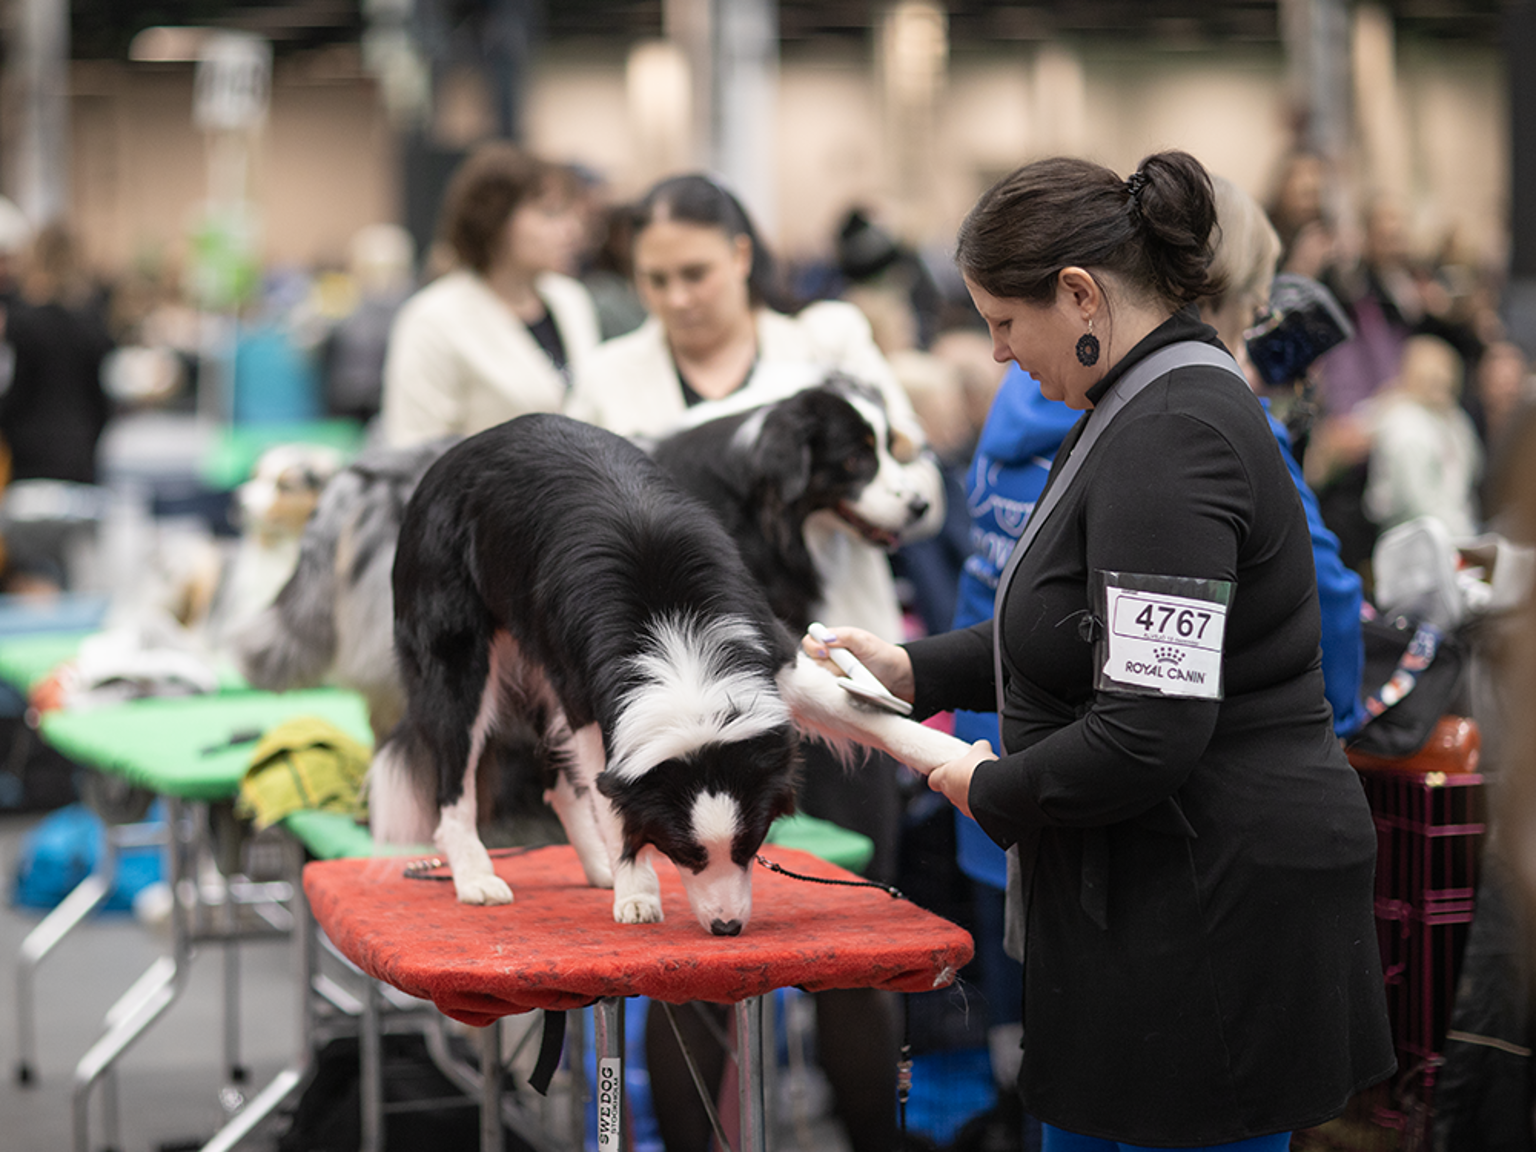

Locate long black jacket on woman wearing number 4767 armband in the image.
[908,309,1393,1146]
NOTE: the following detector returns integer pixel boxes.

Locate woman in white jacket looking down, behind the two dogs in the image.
[567,168,945,1152]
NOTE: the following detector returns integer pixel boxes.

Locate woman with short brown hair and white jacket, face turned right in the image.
[384,141,598,444]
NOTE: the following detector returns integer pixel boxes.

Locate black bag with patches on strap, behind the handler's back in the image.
[1349,616,1467,760]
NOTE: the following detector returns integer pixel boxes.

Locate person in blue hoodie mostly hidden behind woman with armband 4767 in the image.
[954,175,1367,1149]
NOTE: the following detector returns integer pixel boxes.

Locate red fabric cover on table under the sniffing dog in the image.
[304,845,972,1026]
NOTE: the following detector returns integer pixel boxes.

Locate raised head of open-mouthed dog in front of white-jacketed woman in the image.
[731,376,928,548]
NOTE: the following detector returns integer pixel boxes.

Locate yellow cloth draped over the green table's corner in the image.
[235,716,370,829]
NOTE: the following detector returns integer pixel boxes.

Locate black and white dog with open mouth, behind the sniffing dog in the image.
[651,375,929,631]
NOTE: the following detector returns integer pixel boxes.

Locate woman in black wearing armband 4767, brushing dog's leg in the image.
[803,152,1393,1152]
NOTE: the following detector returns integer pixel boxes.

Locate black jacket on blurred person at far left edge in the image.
[0,304,112,484]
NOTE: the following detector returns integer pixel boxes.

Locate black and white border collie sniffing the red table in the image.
[369,415,965,935]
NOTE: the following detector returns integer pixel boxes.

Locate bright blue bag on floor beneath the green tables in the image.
[11,803,163,912]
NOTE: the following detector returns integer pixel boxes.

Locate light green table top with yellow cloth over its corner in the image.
[41,688,373,800]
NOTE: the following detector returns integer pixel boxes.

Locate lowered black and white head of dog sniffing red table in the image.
[598,616,799,935]
